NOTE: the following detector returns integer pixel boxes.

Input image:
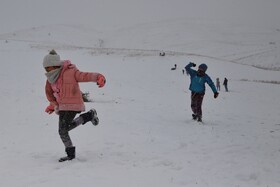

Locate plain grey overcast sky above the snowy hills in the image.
[0,0,280,33]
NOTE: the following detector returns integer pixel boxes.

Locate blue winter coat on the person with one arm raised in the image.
[185,62,217,93]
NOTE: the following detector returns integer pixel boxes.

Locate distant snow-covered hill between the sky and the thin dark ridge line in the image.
[0,20,280,71]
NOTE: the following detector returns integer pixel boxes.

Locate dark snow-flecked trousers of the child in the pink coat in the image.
[58,111,81,148]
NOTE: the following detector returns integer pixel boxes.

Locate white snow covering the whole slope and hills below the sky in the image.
[0,5,280,187]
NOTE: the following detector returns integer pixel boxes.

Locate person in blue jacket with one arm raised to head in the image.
[185,62,219,122]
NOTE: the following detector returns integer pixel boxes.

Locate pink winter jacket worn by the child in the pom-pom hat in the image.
[45,60,99,111]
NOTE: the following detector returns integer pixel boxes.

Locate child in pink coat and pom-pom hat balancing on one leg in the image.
[43,50,106,162]
